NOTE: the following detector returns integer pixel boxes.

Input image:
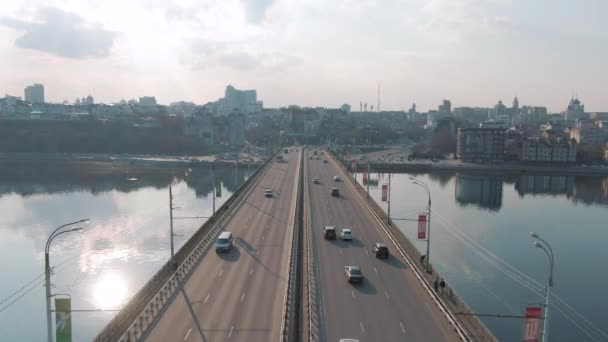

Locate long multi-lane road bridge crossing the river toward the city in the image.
[95,149,496,342]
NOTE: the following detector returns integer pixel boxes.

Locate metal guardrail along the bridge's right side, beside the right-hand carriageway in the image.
[330,153,498,342]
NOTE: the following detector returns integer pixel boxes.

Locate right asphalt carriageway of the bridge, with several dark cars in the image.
[304,151,458,342]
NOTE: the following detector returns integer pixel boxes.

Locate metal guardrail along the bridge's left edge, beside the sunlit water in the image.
[93,156,274,342]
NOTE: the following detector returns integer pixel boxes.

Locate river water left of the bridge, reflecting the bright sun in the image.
[0,162,253,341]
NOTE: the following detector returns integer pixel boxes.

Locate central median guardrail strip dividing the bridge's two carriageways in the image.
[281,150,304,342]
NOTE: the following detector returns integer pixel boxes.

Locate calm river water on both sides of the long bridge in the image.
[0,163,608,341]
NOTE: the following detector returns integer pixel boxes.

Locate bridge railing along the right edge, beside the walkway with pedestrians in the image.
[330,152,498,342]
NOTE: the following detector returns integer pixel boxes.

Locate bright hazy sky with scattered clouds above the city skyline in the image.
[0,0,608,111]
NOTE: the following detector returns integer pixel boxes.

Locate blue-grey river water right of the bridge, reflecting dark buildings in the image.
[358,173,608,341]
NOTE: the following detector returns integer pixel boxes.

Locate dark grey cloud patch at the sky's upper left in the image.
[0,7,116,59]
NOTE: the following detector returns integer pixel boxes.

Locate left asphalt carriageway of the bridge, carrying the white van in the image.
[146,152,299,342]
